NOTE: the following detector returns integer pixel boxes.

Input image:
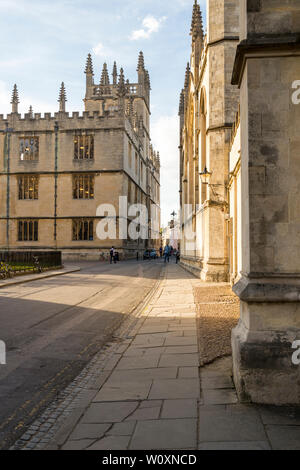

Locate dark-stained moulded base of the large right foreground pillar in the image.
[232,279,300,405]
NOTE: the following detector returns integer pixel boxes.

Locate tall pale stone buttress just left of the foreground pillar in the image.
[201,0,239,281]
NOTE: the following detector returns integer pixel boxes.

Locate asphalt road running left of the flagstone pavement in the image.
[0,260,163,449]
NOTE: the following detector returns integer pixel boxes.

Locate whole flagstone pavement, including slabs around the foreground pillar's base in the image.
[14,263,300,450]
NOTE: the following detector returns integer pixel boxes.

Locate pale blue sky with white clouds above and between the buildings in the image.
[0,0,205,228]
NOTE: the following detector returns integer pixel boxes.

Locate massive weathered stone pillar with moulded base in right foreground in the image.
[232,0,300,404]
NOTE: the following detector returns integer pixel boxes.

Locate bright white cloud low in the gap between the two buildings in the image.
[151,114,179,225]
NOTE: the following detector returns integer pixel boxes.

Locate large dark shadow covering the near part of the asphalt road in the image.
[0,298,127,449]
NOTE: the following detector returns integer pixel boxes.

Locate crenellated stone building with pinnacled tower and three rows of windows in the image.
[0,52,160,259]
